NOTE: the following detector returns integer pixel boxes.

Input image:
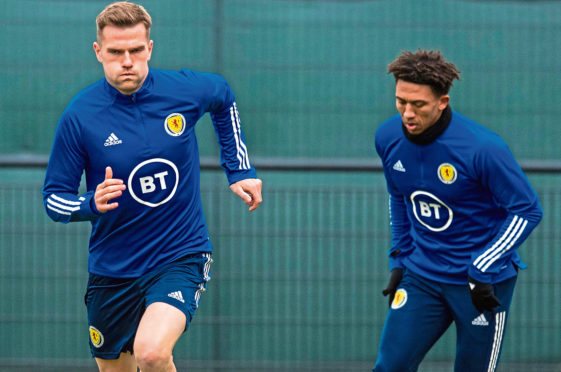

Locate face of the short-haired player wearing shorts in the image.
[93,23,153,94]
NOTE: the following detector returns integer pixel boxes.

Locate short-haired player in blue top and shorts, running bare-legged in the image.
[43,2,262,372]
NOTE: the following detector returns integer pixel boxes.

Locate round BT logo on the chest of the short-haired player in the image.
[127,158,179,208]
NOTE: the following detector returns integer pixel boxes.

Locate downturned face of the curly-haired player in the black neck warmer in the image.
[395,80,450,135]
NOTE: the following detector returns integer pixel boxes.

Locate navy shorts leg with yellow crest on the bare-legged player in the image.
[85,274,144,359]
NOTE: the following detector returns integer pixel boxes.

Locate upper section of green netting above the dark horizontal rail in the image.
[0,0,561,159]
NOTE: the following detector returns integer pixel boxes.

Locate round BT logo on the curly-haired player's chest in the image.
[411,191,454,231]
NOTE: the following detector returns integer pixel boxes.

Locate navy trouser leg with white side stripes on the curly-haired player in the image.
[447,277,516,372]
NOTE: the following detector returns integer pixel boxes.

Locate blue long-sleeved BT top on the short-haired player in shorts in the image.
[42,69,256,277]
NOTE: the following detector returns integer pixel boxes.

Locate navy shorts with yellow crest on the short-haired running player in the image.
[85,253,212,359]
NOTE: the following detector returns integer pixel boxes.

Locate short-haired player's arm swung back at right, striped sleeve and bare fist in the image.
[209,75,262,211]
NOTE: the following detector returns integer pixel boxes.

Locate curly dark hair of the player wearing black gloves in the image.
[388,49,460,96]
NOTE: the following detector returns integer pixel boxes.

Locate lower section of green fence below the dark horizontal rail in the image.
[0,170,561,372]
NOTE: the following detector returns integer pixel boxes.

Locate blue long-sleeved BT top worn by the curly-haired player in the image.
[375,111,543,284]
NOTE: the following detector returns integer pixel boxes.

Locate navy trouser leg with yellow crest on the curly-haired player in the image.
[374,271,452,371]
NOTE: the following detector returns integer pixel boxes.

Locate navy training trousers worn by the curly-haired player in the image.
[374,269,516,372]
